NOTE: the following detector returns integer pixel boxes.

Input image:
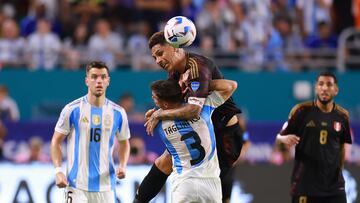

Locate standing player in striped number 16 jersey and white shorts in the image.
[51,61,130,203]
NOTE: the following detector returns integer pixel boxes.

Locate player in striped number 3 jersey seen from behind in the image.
[151,80,237,203]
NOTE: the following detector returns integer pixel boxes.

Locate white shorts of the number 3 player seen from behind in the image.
[171,177,222,203]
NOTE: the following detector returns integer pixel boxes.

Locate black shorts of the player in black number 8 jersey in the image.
[292,194,346,203]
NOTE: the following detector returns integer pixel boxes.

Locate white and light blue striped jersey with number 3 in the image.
[154,91,225,179]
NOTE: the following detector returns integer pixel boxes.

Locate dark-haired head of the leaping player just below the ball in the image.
[149,32,185,72]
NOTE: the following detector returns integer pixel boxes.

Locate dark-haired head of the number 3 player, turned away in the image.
[151,80,183,109]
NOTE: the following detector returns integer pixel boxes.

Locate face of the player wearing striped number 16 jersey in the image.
[85,68,110,97]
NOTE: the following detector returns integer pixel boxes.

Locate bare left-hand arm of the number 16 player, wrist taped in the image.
[51,131,68,188]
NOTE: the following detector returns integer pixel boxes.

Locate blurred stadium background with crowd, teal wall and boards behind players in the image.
[0,0,360,203]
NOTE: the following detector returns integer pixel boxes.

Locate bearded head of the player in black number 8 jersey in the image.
[315,72,339,105]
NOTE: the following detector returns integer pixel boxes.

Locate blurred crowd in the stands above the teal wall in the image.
[0,0,360,71]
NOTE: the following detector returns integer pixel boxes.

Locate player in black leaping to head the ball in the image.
[134,32,242,202]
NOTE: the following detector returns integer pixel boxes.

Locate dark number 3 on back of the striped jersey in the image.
[181,131,205,166]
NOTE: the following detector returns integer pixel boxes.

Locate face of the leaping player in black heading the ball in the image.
[151,44,176,72]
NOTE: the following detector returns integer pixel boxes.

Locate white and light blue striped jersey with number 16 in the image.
[55,96,130,192]
